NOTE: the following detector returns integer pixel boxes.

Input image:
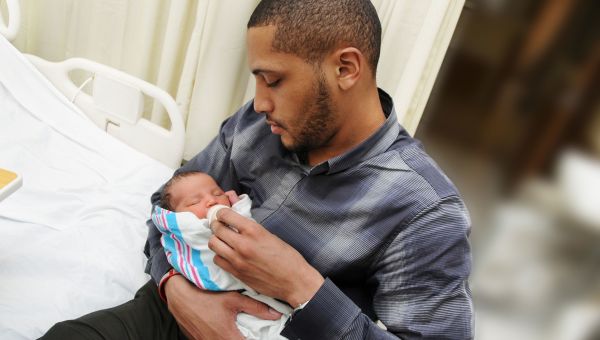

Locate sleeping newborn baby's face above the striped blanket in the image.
[169,174,231,218]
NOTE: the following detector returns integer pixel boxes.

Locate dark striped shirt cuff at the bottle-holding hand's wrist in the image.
[281,278,361,339]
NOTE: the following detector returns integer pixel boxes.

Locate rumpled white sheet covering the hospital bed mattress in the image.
[0,36,172,339]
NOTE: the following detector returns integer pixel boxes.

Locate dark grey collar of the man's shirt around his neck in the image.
[309,89,401,175]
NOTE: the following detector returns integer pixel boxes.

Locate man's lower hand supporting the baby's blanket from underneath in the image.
[165,275,281,340]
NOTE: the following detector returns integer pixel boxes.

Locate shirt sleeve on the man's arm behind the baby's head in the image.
[144,103,245,284]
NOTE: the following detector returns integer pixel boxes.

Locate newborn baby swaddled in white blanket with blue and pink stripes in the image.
[152,172,292,339]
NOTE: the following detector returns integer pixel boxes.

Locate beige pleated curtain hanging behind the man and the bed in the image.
[7,0,464,159]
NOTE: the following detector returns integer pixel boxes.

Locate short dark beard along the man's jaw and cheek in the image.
[285,72,335,153]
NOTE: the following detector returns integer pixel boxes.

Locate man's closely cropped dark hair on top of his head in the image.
[248,0,381,77]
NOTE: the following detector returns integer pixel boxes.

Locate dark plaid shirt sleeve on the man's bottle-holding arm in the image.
[282,197,473,339]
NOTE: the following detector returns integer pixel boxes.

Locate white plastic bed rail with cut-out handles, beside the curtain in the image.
[26,54,185,169]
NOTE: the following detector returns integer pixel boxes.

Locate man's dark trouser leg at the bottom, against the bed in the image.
[40,280,185,340]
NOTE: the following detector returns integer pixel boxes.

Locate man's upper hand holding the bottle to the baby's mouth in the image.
[208,209,325,307]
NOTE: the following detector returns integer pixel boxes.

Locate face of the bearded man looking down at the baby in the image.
[248,26,339,152]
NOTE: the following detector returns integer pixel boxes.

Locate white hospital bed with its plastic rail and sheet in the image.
[0,1,184,339]
